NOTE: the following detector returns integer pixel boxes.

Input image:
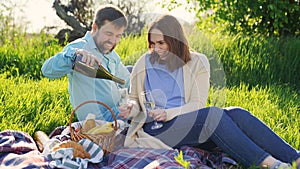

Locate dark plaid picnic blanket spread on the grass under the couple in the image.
[0,128,239,169]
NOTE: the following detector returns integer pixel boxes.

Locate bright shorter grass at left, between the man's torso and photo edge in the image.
[0,77,72,135]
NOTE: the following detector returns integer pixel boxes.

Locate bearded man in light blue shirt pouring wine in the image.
[42,5,130,121]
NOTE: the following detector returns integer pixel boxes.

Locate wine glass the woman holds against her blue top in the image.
[141,91,163,130]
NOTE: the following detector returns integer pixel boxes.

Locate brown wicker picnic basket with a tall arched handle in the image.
[69,100,118,156]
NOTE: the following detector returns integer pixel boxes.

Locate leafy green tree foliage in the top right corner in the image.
[164,0,300,36]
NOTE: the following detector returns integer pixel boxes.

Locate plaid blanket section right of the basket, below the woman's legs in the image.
[101,146,239,169]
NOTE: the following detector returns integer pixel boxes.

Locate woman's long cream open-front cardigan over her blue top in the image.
[124,52,210,149]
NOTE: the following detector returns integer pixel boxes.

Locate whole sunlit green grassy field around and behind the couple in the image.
[0,28,300,150]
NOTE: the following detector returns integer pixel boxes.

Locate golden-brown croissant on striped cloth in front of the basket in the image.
[52,140,91,158]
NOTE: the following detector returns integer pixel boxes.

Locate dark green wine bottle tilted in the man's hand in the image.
[73,55,125,85]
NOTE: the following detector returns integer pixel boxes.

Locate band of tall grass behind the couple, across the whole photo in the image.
[0,26,300,89]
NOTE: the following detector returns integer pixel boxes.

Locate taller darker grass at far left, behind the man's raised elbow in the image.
[0,34,62,79]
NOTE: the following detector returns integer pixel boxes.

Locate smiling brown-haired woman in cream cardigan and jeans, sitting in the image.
[119,15,300,168]
